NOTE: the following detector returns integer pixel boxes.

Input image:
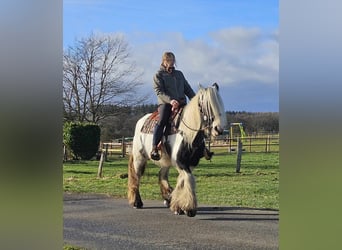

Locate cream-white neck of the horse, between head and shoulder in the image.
[179,95,201,145]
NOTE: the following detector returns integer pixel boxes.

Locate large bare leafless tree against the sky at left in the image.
[63,34,146,123]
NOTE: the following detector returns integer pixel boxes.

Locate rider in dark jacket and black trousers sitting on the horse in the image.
[151,52,211,160]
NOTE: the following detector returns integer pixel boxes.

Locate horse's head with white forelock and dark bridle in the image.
[199,83,227,137]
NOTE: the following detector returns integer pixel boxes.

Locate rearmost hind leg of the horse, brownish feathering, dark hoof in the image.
[127,155,146,208]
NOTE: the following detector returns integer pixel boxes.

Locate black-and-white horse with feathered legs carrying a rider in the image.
[127,83,227,217]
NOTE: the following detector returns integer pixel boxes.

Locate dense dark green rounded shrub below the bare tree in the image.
[63,122,101,160]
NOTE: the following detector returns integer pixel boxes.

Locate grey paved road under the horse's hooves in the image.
[63,194,279,250]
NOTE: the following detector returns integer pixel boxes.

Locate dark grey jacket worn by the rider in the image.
[153,66,195,105]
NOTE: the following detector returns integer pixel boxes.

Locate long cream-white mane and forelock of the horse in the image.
[179,87,223,145]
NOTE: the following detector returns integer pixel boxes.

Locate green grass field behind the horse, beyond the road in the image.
[63,150,279,209]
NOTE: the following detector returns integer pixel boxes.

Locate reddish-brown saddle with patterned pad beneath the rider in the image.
[141,107,183,136]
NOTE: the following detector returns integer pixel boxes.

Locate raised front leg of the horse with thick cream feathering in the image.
[170,170,197,213]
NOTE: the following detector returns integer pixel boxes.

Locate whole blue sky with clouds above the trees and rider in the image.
[63,0,279,112]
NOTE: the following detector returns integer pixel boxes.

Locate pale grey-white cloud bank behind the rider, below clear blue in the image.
[122,27,279,111]
